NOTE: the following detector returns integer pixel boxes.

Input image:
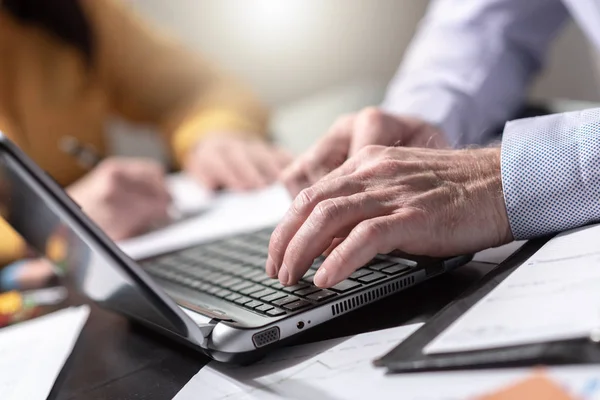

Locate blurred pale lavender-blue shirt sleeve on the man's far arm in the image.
[382,0,569,147]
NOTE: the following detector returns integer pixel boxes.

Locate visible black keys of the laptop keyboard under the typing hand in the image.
[142,229,410,317]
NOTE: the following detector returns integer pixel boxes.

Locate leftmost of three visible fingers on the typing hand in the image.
[267,179,363,277]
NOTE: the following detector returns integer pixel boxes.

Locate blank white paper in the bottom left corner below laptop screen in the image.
[0,306,89,400]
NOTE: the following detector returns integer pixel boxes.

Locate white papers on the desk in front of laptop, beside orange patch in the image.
[174,324,600,400]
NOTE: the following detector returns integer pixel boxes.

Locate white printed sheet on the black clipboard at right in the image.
[424,225,600,354]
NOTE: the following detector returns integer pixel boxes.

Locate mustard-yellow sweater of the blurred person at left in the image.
[0,0,267,263]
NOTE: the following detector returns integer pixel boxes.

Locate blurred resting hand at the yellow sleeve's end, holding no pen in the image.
[185,133,292,190]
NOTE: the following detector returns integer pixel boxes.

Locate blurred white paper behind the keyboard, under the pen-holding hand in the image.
[119,179,291,260]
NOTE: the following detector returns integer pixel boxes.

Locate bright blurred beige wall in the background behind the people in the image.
[125,0,600,105]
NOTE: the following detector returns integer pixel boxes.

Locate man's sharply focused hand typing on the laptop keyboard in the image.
[266,146,512,287]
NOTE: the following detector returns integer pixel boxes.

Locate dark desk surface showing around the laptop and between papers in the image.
[49,262,494,400]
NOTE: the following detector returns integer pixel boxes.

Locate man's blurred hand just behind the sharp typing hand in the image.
[282,107,448,196]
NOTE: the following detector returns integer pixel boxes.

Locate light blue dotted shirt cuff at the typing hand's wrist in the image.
[501,109,600,240]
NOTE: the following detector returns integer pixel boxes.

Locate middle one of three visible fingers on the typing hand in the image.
[279,193,389,285]
